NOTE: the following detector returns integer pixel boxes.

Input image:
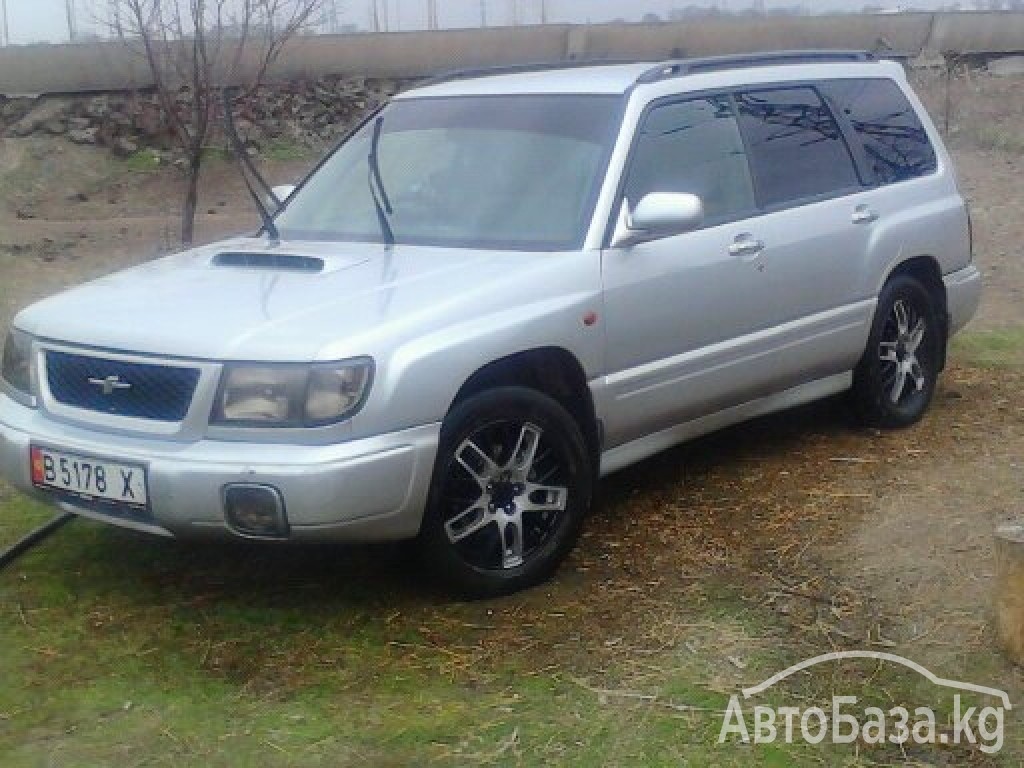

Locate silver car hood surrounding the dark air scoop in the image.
[15,239,577,361]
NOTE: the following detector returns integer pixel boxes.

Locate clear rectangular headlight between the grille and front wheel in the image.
[212,357,374,427]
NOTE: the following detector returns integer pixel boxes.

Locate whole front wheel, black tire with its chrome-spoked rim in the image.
[419,387,594,598]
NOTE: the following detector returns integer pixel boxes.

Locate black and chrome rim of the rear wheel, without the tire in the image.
[879,299,928,406]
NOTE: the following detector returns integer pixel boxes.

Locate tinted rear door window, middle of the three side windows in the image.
[736,88,860,207]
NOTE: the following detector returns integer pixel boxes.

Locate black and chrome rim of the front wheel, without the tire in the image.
[440,420,571,570]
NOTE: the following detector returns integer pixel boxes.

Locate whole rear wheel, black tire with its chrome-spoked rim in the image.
[853,274,946,428]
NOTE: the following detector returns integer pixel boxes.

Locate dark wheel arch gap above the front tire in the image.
[445,346,601,471]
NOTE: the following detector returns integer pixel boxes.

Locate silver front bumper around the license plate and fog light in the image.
[0,394,440,541]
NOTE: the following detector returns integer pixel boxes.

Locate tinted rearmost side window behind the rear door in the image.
[822,80,937,184]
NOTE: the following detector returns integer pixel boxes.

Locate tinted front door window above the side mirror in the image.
[626,96,757,222]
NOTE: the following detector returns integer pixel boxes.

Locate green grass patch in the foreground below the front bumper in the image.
[0,500,741,766]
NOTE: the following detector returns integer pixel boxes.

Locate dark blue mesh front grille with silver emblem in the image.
[46,349,199,421]
